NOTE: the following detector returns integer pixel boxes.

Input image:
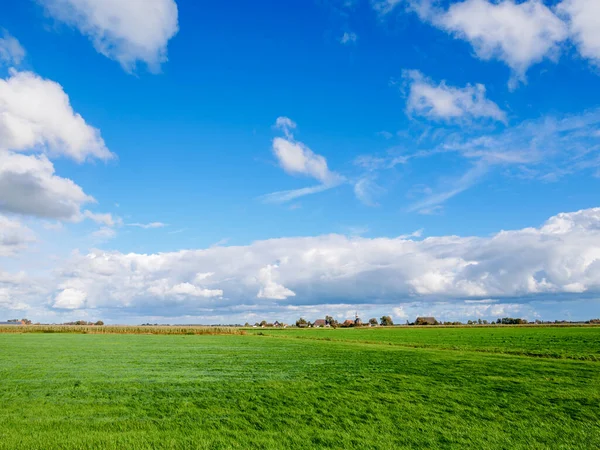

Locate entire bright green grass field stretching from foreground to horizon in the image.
[0,327,600,449]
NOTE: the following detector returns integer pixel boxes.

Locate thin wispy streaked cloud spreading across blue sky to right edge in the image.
[364,109,600,214]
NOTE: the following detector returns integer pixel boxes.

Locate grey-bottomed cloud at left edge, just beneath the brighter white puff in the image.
[0,151,94,221]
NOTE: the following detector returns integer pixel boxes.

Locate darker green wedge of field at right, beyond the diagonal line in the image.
[247,326,600,361]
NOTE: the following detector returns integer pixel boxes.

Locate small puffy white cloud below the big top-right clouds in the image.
[404,70,506,123]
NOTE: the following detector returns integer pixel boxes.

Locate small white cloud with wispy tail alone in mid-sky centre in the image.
[263,117,344,203]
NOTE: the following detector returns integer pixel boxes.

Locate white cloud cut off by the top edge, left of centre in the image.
[38,0,179,72]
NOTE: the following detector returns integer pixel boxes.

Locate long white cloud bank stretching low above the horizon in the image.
[32,208,600,316]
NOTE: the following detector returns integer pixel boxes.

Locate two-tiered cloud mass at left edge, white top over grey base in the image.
[0,69,120,226]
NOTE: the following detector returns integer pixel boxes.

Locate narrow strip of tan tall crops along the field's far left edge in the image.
[0,325,246,335]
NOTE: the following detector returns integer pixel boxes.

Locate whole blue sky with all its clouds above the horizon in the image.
[0,0,600,324]
